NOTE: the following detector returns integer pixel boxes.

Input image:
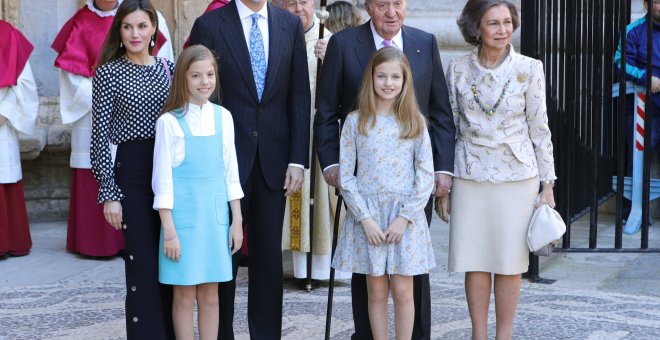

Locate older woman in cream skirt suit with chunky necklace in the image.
[447,0,556,339]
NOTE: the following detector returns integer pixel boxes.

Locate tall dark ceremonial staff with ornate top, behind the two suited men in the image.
[305,0,329,292]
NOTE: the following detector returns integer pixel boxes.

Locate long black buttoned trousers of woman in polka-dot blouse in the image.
[114,139,175,339]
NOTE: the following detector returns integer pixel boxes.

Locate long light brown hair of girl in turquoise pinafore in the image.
[161,45,220,114]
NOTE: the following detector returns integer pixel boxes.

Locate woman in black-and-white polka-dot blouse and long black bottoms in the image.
[90,0,174,339]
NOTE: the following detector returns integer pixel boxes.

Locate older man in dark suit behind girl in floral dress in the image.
[314,0,455,339]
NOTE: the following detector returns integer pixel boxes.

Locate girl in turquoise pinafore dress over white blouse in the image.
[152,45,243,339]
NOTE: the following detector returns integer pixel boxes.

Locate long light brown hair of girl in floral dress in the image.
[358,47,426,139]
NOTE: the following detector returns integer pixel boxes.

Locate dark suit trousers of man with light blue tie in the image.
[218,158,286,340]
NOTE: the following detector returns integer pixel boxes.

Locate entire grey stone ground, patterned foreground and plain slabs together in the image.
[0,217,660,340]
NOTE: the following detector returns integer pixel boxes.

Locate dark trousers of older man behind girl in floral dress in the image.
[351,198,433,340]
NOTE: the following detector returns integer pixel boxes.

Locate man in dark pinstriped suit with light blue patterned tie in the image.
[190,0,311,339]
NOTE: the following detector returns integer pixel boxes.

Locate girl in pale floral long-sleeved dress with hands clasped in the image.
[332,47,435,340]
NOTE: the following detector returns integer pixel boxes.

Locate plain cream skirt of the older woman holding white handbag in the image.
[449,177,539,275]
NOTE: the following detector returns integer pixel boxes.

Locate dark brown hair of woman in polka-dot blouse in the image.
[97,0,158,67]
